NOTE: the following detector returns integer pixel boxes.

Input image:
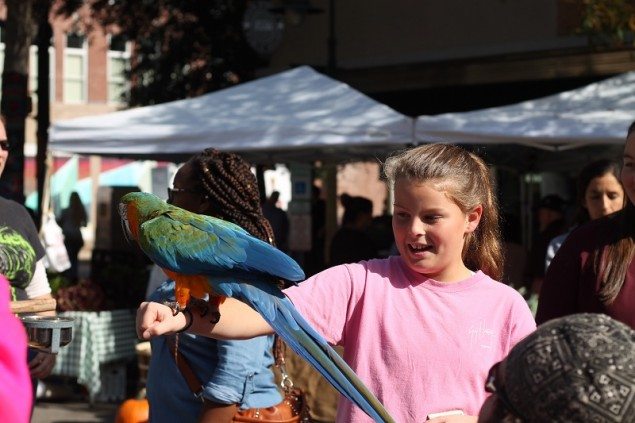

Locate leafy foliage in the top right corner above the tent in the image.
[579,0,635,47]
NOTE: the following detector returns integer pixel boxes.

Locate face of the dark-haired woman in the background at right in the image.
[584,173,624,220]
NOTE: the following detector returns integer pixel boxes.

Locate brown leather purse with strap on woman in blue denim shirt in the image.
[167,335,311,423]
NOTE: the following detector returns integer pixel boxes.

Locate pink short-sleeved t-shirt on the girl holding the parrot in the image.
[285,256,536,423]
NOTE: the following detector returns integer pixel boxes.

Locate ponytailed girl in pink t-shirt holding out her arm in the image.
[137,144,535,423]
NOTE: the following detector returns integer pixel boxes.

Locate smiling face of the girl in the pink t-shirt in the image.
[392,179,482,282]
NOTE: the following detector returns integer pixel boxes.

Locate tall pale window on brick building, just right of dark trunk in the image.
[64,33,88,103]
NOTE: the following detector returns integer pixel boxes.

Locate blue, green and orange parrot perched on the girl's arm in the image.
[119,192,394,423]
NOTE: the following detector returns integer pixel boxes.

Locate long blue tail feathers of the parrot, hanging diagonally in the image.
[208,277,394,422]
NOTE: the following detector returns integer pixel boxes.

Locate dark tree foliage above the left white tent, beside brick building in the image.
[58,0,262,106]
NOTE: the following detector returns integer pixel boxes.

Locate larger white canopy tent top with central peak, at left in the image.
[49,66,414,163]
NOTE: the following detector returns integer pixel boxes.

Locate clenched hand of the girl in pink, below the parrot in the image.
[137,302,187,340]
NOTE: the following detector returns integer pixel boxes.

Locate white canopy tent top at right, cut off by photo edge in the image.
[415,72,635,151]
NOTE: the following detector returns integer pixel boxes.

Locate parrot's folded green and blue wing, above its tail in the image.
[139,212,304,282]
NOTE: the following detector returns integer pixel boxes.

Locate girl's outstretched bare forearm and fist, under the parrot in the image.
[137,298,273,340]
